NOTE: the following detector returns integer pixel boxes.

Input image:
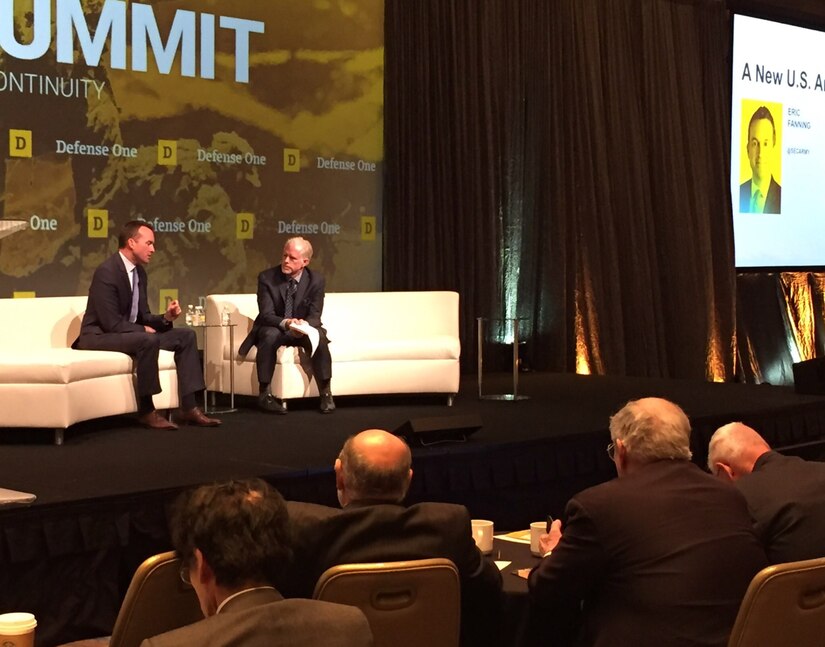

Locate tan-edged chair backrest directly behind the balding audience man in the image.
[313,558,461,647]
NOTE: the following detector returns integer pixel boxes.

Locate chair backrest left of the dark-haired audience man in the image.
[109,552,203,647]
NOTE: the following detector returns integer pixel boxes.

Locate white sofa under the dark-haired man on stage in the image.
[0,296,178,445]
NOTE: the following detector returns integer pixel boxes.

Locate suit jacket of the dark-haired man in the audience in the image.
[141,589,372,647]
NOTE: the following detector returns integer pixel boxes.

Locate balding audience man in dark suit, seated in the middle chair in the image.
[284,429,501,646]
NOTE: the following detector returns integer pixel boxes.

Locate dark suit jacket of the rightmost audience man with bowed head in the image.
[736,452,825,564]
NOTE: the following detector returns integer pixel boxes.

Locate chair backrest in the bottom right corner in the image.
[728,557,825,647]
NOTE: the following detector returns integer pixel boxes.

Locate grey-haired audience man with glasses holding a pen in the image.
[529,398,767,647]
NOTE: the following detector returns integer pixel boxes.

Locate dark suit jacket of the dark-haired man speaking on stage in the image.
[80,253,172,335]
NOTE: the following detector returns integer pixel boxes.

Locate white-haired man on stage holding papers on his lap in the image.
[238,237,335,414]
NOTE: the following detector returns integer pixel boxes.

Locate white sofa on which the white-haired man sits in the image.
[204,292,461,404]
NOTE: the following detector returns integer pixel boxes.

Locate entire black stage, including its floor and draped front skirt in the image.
[0,373,825,645]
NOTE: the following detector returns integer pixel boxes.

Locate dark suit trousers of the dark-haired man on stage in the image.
[77,328,205,400]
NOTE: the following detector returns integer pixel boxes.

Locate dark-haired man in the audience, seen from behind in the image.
[142,479,372,647]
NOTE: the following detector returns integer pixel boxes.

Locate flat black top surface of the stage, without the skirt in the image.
[6,373,825,506]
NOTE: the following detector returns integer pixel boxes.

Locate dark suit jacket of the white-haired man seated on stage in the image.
[238,265,326,355]
